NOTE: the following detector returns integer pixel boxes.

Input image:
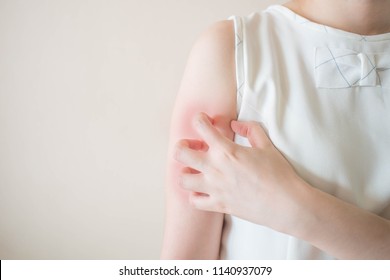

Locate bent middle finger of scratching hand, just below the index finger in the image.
[174,140,206,172]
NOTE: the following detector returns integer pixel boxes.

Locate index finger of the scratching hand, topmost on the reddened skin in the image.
[194,113,228,149]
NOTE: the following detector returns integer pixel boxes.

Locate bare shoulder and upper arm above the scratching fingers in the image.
[172,20,237,138]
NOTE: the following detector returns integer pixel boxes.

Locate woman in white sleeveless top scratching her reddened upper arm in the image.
[162,0,390,259]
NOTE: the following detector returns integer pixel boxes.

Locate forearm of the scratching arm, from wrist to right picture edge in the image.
[291,178,390,259]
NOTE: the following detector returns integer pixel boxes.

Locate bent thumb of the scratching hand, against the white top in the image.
[231,121,272,148]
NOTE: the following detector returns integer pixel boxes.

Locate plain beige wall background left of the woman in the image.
[0,0,284,259]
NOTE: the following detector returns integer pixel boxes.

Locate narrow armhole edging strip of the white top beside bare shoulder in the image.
[229,16,245,115]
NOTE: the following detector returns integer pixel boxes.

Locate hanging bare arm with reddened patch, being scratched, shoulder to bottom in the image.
[161,21,236,259]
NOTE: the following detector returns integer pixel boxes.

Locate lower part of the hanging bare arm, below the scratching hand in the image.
[161,163,223,259]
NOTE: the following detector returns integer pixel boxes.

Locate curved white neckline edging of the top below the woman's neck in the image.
[268,5,390,42]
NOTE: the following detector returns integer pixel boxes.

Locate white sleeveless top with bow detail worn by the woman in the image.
[221,6,390,259]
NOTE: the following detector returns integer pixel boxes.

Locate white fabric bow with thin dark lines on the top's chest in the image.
[315,47,390,89]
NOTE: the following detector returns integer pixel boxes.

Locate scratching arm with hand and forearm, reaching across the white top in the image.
[176,114,390,259]
